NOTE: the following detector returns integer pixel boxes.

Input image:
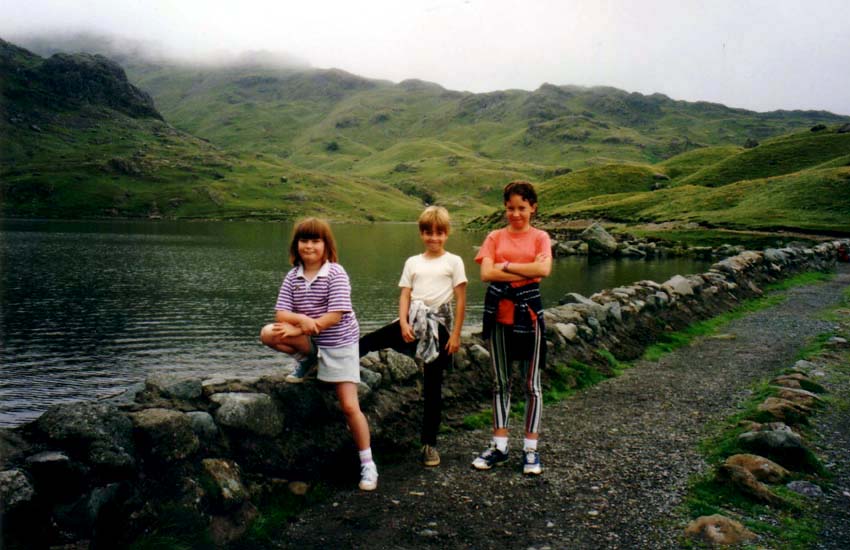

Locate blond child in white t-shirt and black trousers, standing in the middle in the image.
[360,206,467,466]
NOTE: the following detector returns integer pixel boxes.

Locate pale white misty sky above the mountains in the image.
[0,0,850,115]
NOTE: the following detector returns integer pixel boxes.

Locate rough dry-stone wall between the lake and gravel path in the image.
[0,241,848,547]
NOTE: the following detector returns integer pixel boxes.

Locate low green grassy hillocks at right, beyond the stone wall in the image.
[541,124,850,233]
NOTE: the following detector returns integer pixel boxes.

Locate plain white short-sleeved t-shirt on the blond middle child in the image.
[398,252,467,308]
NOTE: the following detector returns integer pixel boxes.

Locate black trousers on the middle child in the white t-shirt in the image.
[360,321,451,445]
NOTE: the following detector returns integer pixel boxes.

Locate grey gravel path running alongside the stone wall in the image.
[280,267,850,549]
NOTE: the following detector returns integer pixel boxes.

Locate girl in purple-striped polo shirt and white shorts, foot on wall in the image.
[260,218,378,491]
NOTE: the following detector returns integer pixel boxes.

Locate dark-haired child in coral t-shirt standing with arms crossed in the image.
[472,181,552,474]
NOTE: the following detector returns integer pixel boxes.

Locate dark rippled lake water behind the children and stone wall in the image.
[0,220,707,426]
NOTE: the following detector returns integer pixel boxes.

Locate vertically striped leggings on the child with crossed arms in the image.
[490,323,546,434]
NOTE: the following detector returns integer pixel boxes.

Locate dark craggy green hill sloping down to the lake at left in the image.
[0,41,421,220]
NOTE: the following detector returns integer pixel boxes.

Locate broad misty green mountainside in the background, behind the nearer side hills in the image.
[124,64,848,222]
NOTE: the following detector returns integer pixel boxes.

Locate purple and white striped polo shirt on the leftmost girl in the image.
[275,262,360,348]
